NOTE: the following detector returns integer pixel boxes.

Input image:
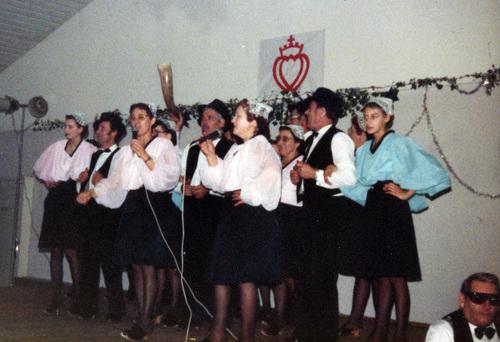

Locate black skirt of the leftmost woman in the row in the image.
[38,179,80,250]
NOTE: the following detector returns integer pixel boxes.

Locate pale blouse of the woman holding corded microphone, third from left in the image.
[94,137,181,208]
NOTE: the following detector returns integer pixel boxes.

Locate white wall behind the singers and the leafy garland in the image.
[0,0,500,322]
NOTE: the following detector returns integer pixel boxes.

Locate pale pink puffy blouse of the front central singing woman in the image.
[199,135,281,211]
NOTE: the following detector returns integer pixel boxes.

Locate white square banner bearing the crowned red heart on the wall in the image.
[257,30,325,98]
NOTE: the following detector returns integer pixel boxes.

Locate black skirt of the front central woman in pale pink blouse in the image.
[207,204,281,285]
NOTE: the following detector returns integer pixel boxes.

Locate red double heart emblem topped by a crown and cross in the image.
[273,35,309,93]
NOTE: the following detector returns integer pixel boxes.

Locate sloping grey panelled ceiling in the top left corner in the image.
[0,0,92,72]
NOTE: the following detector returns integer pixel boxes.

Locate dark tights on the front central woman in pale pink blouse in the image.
[211,283,257,342]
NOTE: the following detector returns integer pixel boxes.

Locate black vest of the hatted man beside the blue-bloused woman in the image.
[304,126,341,206]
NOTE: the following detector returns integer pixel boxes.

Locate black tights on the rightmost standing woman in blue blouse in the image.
[372,277,410,341]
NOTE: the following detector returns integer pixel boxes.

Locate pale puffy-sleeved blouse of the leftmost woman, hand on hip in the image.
[33,139,97,182]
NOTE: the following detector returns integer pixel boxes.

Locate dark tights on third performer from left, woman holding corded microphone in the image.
[132,264,158,330]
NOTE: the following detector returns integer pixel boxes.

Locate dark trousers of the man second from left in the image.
[79,201,125,317]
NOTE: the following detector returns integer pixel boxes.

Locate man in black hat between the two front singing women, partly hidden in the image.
[170,99,233,326]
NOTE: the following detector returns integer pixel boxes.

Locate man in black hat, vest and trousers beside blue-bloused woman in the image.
[290,88,356,342]
